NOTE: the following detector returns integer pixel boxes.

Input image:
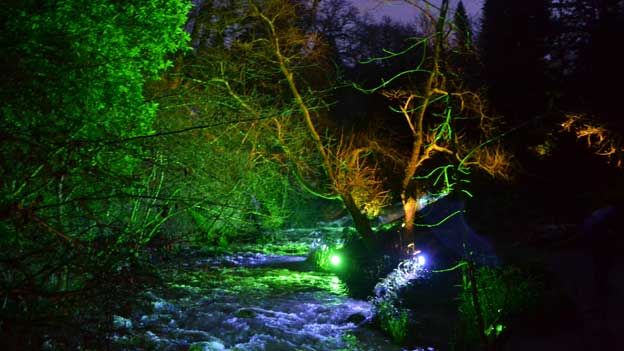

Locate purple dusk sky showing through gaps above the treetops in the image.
[351,0,483,22]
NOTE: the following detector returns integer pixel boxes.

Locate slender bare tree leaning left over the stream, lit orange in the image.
[173,0,386,242]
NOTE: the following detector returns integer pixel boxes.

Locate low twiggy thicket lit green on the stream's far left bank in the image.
[154,84,305,248]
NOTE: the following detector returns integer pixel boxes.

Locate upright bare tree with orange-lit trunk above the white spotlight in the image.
[358,0,510,247]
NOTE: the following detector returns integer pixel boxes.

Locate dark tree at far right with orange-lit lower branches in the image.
[550,0,624,166]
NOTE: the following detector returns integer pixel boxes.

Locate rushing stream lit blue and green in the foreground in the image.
[113,253,414,351]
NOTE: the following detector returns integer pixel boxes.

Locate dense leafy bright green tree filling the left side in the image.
[0,0,189,349]
